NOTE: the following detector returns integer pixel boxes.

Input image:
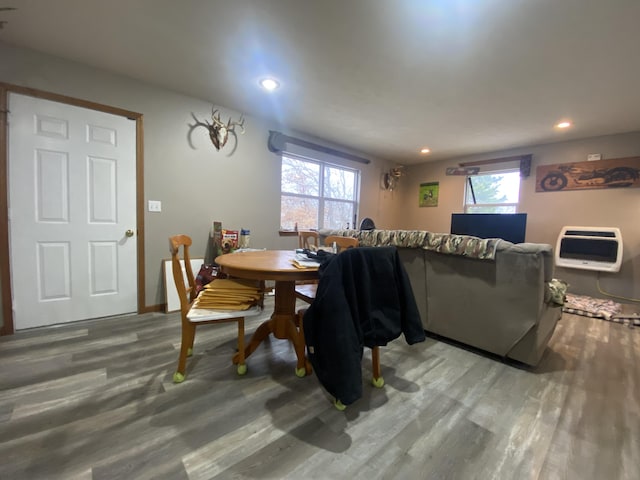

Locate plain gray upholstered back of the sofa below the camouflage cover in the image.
[425,251,546,356]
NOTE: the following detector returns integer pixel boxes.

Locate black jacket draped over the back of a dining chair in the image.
[303,247,425,405]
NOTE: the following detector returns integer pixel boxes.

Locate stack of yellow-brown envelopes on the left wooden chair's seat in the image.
[193,278,262,310]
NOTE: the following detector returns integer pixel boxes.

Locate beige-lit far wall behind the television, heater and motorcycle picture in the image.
[398,132,640,302]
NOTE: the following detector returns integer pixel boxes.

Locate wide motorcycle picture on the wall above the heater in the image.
[536,157,640,192]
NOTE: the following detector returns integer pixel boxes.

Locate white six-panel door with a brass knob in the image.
[8,93,138,330]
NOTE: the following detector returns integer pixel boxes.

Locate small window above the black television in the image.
[464,169,520,213]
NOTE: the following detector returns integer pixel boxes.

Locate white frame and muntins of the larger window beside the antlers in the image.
[280,151,362,232]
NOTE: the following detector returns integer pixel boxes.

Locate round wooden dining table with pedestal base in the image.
[215,250,318,377]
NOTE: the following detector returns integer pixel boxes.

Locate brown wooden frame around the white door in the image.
[0,82,146,335]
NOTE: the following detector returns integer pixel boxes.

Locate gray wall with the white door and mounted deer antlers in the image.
[0,43,398,326]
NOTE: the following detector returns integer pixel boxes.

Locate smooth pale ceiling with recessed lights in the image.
[0,0,640,164]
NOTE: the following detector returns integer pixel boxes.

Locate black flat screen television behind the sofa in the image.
[451,213,527,243]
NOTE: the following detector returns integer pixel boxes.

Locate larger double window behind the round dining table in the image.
[280,155,360,230]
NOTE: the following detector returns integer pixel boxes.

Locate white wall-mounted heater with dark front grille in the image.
[555,227,622,272]
